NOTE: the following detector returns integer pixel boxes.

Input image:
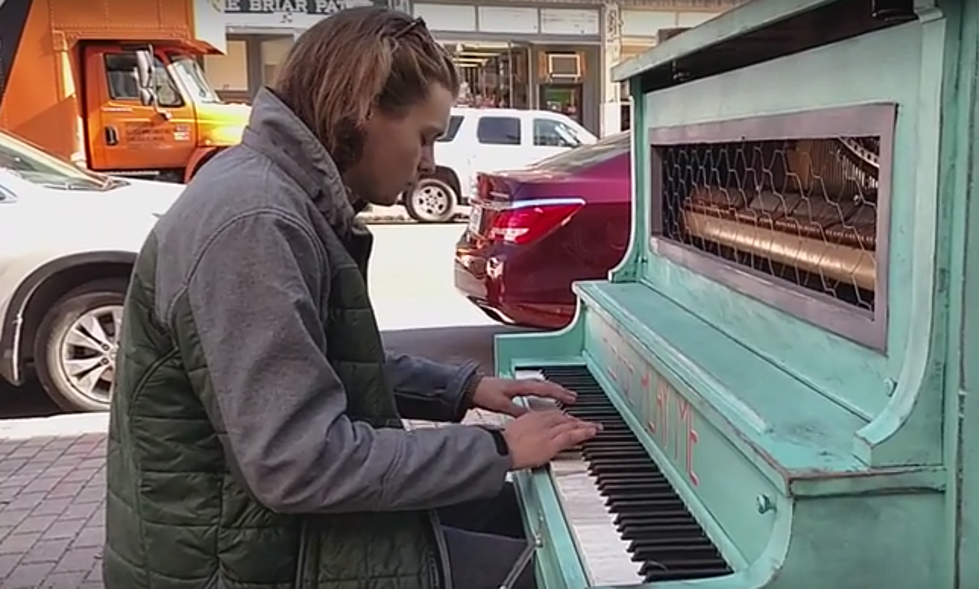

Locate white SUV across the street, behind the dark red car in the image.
[404,108,597,223]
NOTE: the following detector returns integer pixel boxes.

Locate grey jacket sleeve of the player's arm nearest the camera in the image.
[171,211,509,513]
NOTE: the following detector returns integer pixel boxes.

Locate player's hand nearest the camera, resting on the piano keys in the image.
[503,409,602,470]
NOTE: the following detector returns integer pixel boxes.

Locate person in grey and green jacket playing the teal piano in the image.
[104,8,596,589]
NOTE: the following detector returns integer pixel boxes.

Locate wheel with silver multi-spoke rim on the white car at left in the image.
[34,279,127,412]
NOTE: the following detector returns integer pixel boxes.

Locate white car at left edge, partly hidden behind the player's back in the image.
[0,131,183,411]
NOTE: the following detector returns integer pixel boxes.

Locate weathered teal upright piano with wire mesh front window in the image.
[496,0,979,589]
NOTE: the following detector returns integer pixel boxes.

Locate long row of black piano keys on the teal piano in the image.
[534,366,731,582]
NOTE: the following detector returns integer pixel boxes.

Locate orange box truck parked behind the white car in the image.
[0,0,249,182]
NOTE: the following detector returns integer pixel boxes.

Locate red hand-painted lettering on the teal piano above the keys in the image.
[601,335,700,486]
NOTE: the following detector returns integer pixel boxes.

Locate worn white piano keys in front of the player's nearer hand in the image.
[551,455,643,586]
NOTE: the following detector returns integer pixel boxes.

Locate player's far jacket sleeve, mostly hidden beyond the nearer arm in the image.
[386,354,479,422]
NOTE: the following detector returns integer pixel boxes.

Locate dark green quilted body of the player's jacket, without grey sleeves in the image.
[103,223,444,589]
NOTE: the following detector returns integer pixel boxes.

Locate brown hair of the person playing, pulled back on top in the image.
[272,6,459,172]
